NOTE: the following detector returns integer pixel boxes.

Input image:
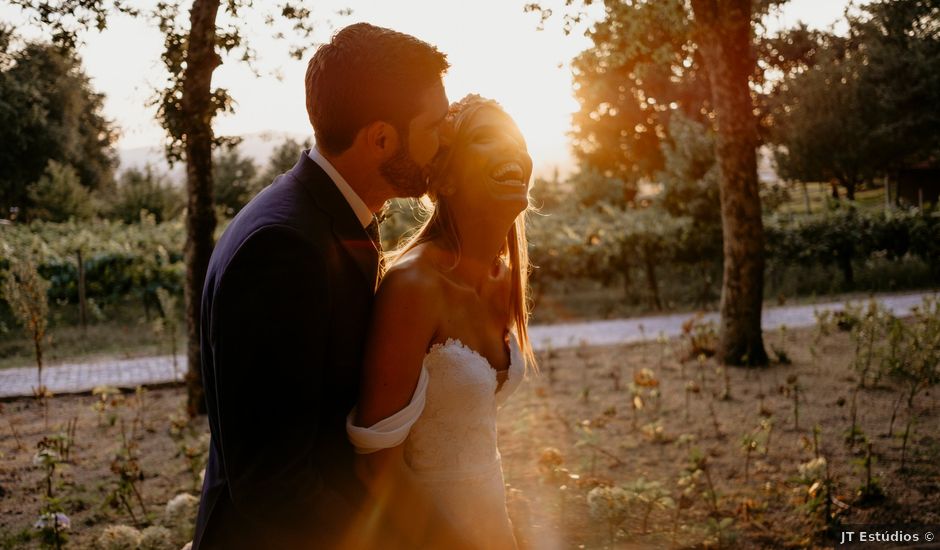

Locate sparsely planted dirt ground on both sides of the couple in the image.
[0,329,940,549]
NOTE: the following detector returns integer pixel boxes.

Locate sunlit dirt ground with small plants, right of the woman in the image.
[500,329,940,548]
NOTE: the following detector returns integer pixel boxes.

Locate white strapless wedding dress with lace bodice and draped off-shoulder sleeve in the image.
[346,335,525,549]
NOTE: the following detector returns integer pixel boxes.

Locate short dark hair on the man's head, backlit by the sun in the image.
[305,23,449,155]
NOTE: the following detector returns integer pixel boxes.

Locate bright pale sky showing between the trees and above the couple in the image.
[0,0,864,175]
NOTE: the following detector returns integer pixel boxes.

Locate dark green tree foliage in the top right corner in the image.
[767,0,940,195]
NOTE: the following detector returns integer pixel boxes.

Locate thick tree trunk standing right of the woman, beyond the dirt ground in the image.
[692,0,768,365]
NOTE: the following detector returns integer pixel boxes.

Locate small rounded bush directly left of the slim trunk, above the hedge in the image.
[106,165,184,223]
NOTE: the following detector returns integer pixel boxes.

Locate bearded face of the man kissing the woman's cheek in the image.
[379,82,448,197]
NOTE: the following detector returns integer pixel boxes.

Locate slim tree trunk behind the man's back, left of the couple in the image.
[181,0,222,416]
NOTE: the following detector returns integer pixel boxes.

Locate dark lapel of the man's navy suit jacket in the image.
[291,151,379,291]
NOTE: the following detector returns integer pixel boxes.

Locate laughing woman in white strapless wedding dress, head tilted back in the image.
[347,95,535,548]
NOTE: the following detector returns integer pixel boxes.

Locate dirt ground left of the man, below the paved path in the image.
[0,388,209,549]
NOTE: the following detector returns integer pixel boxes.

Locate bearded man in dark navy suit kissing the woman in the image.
[193,23,448,549]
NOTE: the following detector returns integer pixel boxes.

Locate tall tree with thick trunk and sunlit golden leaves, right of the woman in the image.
[526,0,787,365]
